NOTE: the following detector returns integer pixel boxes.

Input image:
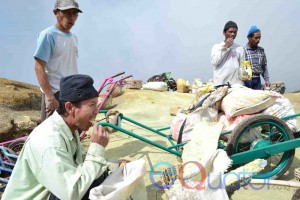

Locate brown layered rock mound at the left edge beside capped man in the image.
[0,78,41,142]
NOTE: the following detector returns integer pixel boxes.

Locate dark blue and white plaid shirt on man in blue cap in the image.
[244,44,269,81]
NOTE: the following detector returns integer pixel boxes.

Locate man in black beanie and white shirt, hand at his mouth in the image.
[211,21,243,86]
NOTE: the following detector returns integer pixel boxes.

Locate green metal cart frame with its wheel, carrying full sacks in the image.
[99,110,300,179]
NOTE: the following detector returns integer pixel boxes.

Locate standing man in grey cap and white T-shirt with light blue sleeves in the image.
[34,0,82,121]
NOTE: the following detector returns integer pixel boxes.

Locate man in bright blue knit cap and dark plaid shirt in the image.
[244,26,271,90]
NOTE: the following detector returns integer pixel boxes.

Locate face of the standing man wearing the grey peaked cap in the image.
[54,8,78,33]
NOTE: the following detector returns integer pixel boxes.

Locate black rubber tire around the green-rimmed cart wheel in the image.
[227,114,295,179]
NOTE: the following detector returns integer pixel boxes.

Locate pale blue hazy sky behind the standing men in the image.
[0,0,300,92]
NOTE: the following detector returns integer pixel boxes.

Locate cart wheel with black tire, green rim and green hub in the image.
[227,114,295,179]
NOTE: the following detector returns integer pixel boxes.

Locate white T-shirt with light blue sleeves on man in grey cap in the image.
[34,26,78,94]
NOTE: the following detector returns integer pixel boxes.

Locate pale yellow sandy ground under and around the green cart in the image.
[84,90,300,200]
